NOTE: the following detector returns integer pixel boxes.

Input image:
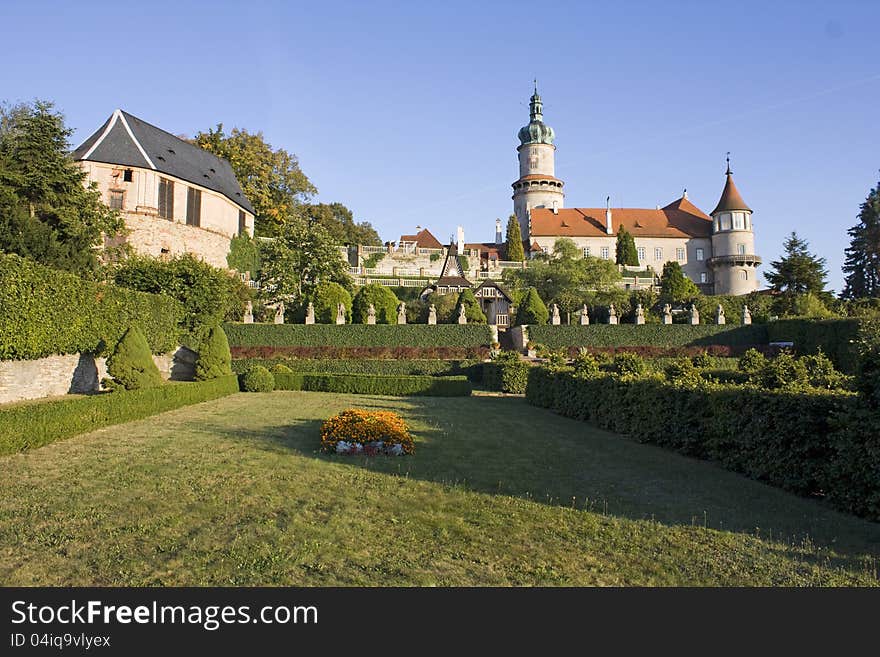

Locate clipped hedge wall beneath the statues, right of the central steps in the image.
[528,324,768,349]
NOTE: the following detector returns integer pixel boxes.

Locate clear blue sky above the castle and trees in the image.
[0,0,880,291]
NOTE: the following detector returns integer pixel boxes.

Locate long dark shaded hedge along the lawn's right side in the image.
[526,368,880,517]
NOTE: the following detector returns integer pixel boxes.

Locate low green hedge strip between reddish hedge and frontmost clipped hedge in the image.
[232,358,483,381]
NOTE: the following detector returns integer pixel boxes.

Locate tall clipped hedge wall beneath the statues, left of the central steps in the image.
[223,324,492,348]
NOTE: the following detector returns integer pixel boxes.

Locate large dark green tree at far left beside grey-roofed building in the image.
[0,101,124,274]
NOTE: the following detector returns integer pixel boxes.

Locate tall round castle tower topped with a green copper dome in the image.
[513,81,565,240]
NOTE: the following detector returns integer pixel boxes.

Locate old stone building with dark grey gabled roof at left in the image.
[73,110,254,268]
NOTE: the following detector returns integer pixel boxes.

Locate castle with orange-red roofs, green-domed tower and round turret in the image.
[513,87,761,294]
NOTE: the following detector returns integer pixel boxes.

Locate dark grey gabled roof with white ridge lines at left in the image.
[72,110,254,214]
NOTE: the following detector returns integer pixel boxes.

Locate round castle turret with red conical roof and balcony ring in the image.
[709,157,761,294]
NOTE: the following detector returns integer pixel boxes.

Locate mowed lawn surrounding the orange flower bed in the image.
[0,392,880,586]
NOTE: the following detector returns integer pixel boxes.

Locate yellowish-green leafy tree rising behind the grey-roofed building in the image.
[191,123,318,235]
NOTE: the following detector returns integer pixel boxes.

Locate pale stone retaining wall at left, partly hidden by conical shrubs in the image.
[0,347,196,404]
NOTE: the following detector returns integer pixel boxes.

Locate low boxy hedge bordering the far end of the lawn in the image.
[275,372,471,397]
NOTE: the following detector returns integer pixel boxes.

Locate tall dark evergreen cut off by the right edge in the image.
[840,177,880,299]
